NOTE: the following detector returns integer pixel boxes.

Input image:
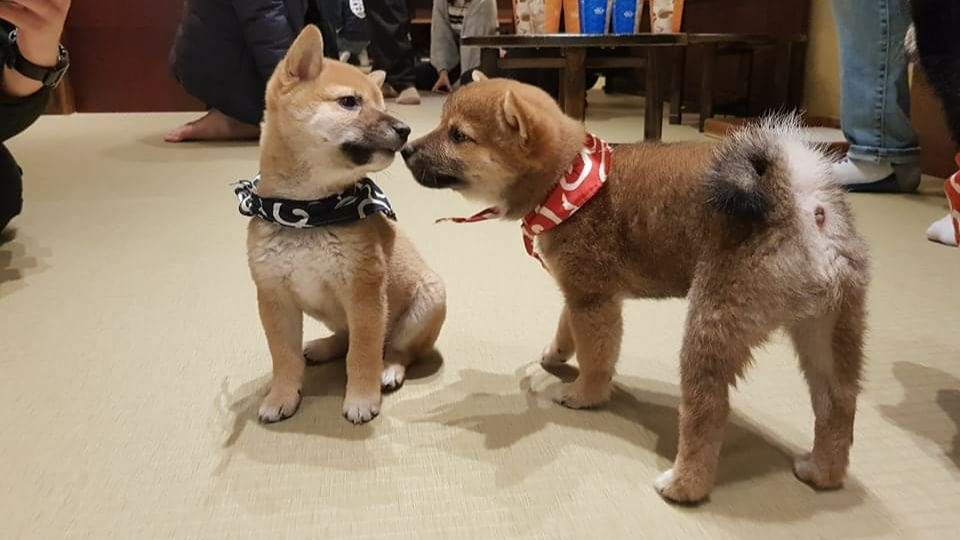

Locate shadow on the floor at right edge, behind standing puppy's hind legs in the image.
[879,362,960,467]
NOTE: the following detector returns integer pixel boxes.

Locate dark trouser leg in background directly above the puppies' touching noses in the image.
[366,0,416,92]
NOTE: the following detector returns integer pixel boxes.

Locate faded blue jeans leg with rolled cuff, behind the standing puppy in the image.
[833,0,920,164]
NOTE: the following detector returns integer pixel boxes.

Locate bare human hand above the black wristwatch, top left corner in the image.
[0,0,70,67]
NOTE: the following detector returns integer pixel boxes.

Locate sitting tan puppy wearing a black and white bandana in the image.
[244,26,446,423]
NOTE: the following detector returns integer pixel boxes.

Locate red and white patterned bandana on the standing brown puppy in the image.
[437,133,613,263]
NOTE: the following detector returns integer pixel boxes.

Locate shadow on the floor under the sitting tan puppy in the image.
[215,351,443,471]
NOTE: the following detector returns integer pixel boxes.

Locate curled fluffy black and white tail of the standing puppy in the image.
[706,115,808,222]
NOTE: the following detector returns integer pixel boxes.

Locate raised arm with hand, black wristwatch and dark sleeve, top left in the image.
[0,0,70,141]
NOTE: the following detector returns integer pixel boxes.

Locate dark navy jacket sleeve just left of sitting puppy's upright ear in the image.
[233,0,296,80]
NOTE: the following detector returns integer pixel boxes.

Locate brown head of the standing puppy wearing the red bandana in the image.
[402,79,568,211]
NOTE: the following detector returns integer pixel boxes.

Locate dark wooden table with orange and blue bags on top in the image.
[463,33,687,140]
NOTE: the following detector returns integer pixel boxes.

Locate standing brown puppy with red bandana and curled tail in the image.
[402,77,868,502]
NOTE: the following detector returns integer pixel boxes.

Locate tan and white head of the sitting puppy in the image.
[266,26,410,179]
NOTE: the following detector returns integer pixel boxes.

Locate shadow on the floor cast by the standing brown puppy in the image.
[392,366,866,522]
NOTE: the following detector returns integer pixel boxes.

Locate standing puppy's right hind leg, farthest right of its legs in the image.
[790,298,864,489]
